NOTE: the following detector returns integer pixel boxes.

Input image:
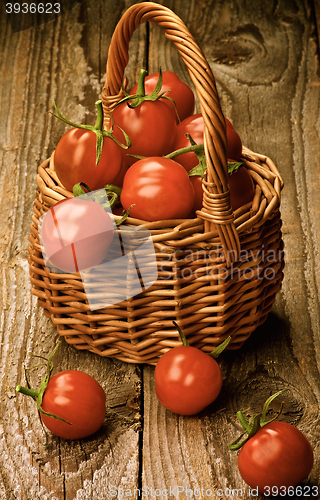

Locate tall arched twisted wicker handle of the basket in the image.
[102,2,240,264]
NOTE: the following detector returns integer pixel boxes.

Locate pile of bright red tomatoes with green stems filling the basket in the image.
[54,70,254,221]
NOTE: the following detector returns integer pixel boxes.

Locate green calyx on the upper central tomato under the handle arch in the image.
[117,67,180,123]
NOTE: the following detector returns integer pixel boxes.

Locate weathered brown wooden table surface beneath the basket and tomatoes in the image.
[0,0,320,500]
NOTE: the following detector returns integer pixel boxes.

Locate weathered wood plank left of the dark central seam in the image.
[0,2,145,500]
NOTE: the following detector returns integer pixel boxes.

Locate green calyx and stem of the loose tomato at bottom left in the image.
[16,341,72,432]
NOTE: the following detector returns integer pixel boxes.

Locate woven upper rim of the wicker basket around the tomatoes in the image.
[36,146,284,253]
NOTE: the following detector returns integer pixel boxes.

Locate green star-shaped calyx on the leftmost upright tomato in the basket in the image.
[51,98,131,166]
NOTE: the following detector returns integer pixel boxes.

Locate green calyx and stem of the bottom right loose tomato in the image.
[229,389,288,451]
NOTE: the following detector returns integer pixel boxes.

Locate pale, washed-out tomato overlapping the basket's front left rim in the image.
[40,198,114,273]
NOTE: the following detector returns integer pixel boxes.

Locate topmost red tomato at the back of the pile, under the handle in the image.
[130,71,194,121]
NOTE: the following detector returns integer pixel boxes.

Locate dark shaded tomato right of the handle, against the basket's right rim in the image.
[228,166,255,211]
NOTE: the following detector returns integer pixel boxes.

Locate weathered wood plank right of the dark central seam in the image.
[143,0,320,498]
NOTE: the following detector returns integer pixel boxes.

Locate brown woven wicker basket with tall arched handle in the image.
[29,2,284,364]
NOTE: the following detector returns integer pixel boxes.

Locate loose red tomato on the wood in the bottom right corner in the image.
[238,421,313,490]
